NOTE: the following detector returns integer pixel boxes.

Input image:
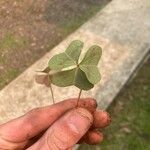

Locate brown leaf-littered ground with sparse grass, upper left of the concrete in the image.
[0,0,110,89]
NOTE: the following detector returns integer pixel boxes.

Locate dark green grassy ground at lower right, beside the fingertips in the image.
[80,58,150,150]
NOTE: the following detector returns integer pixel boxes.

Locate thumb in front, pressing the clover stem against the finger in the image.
[29,108,93,150]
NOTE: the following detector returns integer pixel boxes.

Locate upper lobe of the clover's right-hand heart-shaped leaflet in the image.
[80,45,102,65]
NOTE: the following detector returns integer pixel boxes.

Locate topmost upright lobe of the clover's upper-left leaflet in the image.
[65,40,83,63]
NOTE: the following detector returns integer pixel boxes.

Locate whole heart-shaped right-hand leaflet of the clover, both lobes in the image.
[79,45,102,84]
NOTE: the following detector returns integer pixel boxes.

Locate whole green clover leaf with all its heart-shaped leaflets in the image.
[36,40,102,90]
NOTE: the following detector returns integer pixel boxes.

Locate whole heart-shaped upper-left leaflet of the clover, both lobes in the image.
[48,40,83,70]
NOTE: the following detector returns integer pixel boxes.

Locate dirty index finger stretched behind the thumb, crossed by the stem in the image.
[0,98,96,143]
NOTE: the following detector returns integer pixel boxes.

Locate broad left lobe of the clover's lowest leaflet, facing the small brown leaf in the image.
[50,69,76,87]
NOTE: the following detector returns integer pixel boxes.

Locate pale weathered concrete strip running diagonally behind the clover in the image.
[0,0,150,134]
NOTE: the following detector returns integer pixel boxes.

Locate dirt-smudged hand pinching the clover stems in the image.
[0,98,111,150]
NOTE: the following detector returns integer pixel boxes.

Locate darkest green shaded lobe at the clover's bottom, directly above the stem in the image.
[74,68,94,90]
